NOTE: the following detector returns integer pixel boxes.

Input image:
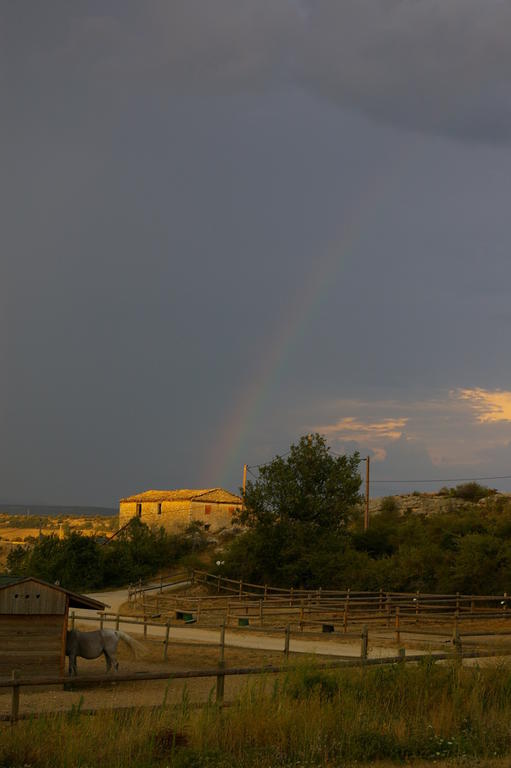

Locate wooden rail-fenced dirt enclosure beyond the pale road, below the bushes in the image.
[130,570,511,634]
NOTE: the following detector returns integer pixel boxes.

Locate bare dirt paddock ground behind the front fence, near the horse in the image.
[0,634,290,716]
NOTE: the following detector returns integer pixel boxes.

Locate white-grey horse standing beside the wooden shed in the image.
[66,629,145,675]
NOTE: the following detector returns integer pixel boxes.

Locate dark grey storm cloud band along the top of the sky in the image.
[4,0,511,142]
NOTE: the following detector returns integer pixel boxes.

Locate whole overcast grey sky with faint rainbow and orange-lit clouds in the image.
[0,0,511,505]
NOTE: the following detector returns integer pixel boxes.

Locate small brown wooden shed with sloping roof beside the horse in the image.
[0,577,105,677]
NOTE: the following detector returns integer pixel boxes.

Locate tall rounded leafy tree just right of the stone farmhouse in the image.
[223,434,361,586]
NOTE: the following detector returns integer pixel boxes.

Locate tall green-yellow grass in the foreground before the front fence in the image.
[0,659,511,768]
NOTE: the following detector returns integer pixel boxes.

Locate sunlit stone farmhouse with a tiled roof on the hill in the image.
[119,488,242,533]
